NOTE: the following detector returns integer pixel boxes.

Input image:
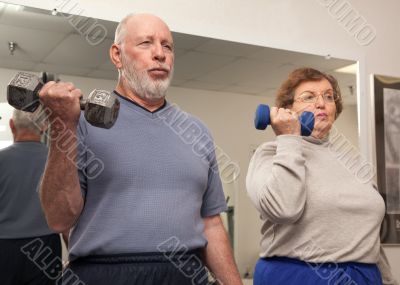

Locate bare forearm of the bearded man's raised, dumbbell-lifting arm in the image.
[40,127,83,232]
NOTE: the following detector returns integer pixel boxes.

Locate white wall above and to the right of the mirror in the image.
[3,0,400,279]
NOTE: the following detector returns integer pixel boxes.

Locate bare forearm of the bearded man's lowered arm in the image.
[204,215,242,285]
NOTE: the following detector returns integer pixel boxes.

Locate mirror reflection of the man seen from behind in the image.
[0,107,61,285]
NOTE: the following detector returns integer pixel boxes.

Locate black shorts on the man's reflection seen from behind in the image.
[0,234,62,285]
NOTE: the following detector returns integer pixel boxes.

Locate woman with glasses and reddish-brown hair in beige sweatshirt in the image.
[246,68,396,285]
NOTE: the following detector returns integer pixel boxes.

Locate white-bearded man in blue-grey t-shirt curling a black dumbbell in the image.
[40,14,241,285]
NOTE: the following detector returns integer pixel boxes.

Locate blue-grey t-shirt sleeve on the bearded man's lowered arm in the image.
[201,136,227,218]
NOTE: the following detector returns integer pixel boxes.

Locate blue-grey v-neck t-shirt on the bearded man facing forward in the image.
[70,93,226,260]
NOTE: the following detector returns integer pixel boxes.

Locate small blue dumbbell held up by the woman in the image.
[254,104,314,136]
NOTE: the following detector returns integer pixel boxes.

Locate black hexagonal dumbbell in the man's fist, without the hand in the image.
[7,72,120,129]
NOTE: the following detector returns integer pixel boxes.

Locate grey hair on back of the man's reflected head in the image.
[12,107,48,135]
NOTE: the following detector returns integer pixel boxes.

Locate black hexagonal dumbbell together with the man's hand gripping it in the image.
[7,72,120,129]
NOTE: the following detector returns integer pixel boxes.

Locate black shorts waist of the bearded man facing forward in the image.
[62,251,213,285]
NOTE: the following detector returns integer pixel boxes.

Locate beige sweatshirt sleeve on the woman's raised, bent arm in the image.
[246,135,306,224]
